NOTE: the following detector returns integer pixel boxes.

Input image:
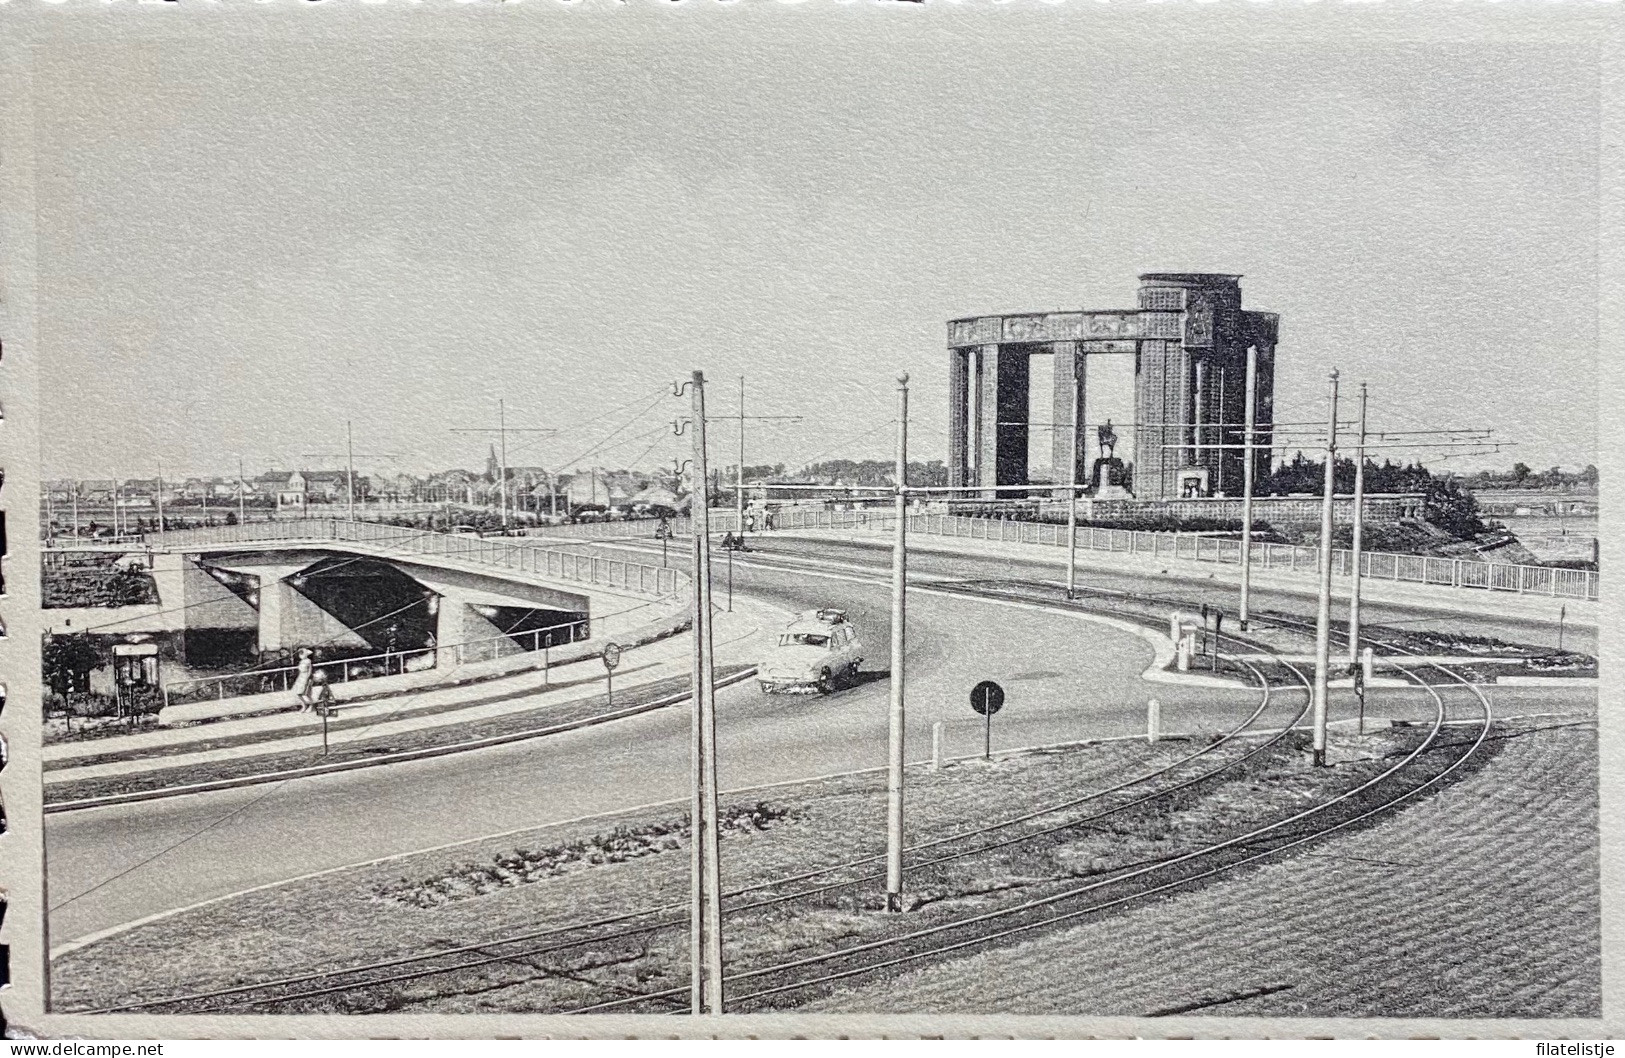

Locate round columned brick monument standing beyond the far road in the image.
[947,273,1279,501]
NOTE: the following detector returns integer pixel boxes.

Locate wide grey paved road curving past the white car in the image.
[47,541,1586,946]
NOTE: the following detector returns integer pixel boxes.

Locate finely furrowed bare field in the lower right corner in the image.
[808,722,1601,1017]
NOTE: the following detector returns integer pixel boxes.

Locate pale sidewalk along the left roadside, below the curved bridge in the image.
[44,596,790,785]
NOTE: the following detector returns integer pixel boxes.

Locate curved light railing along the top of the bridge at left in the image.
[146,518,689,596]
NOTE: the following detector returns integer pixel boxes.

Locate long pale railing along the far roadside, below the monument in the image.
[772,509,1599,600]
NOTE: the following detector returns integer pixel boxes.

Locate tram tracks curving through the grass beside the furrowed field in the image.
[73,565,1490,1012]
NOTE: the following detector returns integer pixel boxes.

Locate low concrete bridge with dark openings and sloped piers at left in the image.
[47,518,689,721]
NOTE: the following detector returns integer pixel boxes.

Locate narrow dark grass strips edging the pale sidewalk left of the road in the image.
[46,665,749,804]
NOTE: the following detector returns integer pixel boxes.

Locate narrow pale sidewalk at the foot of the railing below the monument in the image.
[772,528,1599,627]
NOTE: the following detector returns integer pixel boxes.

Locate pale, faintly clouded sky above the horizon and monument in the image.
[25,5,1597,478]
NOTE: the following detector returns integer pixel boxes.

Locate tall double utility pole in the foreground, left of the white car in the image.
[689,371,723,1014]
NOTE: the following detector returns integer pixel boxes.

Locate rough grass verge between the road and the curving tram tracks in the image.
[54,715,1489,1012]
